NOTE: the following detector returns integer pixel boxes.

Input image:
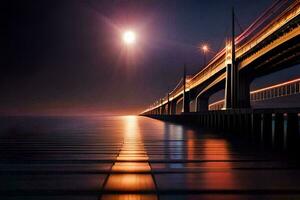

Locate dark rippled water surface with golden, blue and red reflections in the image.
[0,116,300,200]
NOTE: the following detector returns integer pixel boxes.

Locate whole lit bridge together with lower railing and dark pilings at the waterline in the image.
[141,0,300,148]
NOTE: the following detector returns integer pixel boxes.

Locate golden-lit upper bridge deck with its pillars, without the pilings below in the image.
[142,1,300,115]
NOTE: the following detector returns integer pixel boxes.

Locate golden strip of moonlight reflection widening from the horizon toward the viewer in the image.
[101,116,157,200]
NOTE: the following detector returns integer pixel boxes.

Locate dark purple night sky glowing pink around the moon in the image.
[0,0,298,114]
